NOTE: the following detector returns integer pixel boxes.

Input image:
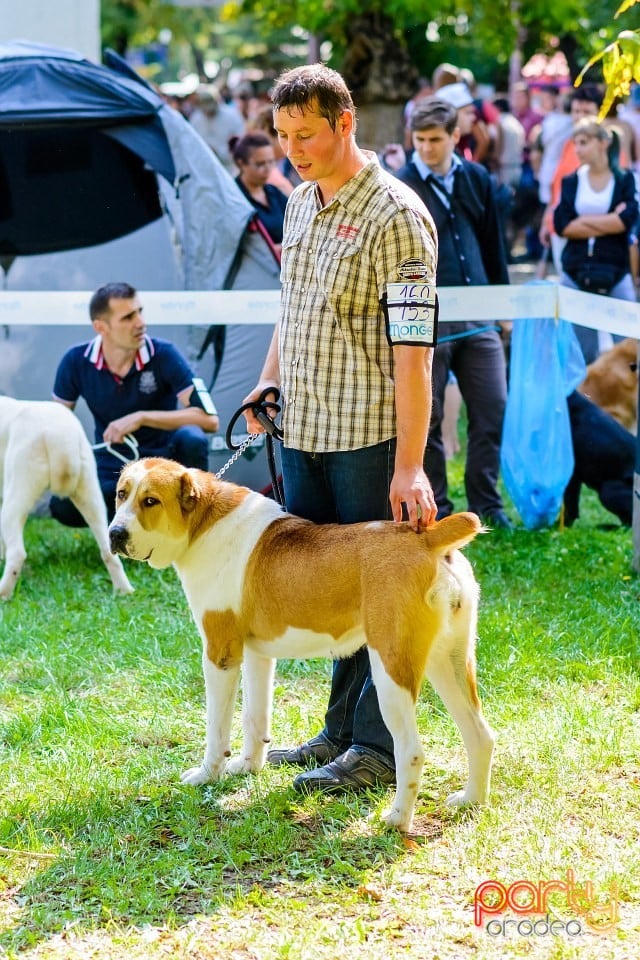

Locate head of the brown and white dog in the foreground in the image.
[109,457,208,569]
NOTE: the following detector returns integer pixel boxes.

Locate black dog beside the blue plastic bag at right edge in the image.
[564,390,636,527]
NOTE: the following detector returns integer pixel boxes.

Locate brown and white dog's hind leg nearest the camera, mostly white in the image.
[369,647,424,833]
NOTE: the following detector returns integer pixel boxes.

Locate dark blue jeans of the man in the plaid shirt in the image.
[281,438,396,767]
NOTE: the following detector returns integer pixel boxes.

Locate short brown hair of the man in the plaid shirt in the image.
[270,63,355,130]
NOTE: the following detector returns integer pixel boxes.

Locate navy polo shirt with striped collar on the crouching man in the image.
[53,337,194,468]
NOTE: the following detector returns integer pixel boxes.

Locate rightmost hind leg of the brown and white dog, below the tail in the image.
[426,601,494,806]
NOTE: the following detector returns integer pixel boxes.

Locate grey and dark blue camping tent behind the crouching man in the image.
[0,41,279,484]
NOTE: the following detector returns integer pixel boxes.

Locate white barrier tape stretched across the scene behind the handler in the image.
[0,281,640,339]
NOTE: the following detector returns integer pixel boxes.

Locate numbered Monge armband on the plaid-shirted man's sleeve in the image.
[382,280,438,347]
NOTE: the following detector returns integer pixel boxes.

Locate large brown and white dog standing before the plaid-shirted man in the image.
[109,458,493,831]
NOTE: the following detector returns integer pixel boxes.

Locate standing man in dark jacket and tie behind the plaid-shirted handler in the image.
[396,96,511,528]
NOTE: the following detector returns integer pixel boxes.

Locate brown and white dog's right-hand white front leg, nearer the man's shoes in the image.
[227,647,276,773]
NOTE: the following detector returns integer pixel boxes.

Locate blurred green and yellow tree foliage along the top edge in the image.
[101,0,640,103]
